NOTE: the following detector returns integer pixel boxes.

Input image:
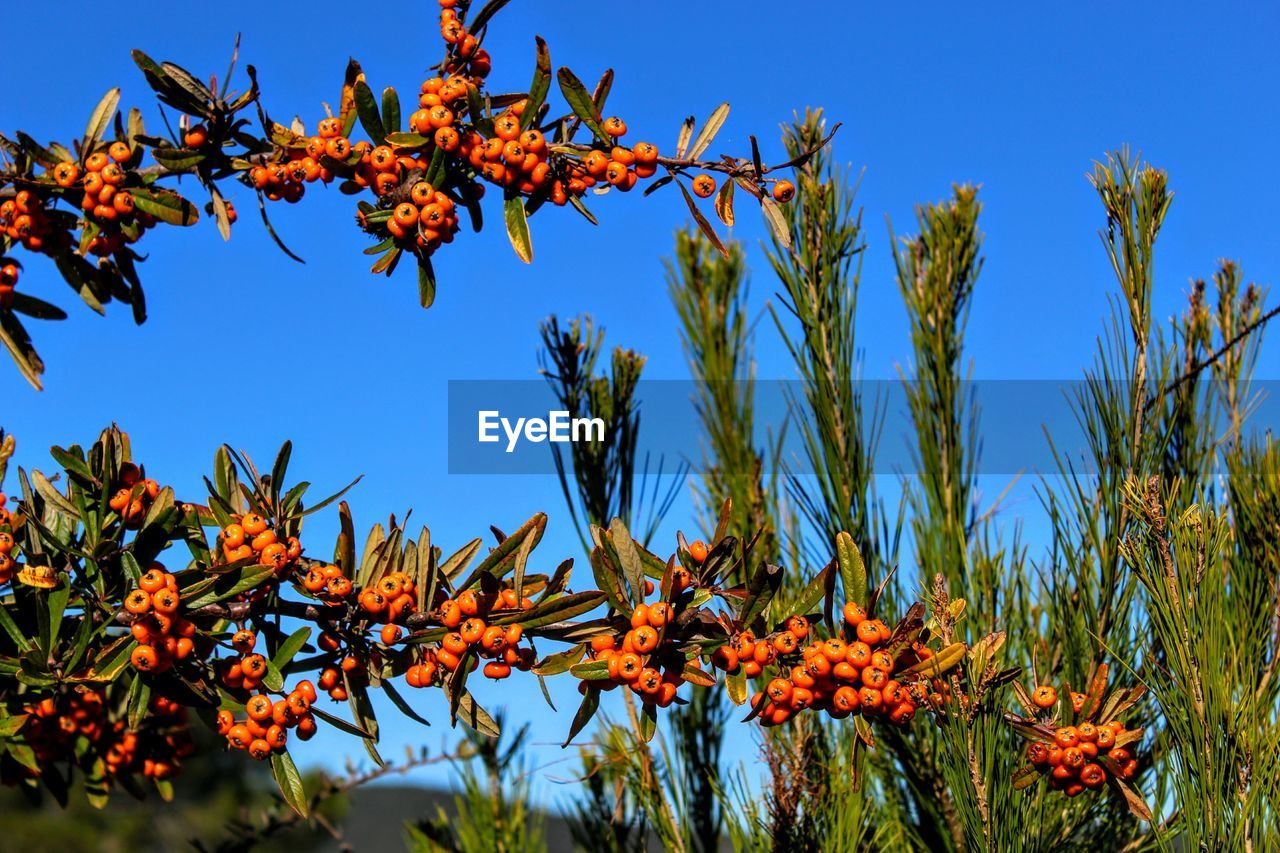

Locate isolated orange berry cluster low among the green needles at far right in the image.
[1027,717,1138,797]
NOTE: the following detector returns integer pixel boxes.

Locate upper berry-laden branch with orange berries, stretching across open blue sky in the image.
[0,0,829,388]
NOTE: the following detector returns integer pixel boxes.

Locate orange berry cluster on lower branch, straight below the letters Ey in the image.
[435,587,535,686]
